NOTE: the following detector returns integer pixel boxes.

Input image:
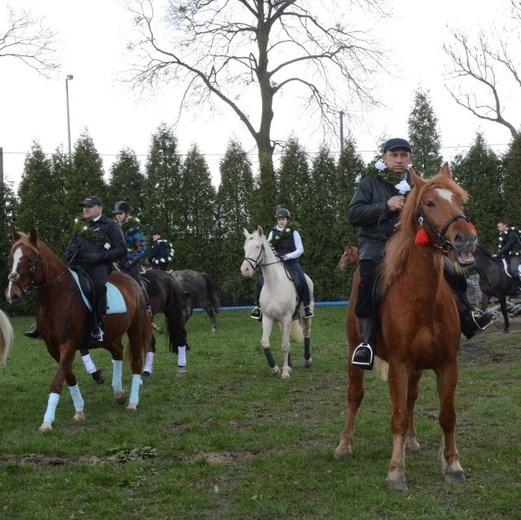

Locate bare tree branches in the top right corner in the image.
[444,4,521,137]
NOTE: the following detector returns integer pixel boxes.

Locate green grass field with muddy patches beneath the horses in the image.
[0,307,521,520]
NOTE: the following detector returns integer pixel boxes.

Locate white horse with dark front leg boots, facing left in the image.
[241,226,314,379]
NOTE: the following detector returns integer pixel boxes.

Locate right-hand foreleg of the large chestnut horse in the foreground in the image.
[436,362,465,482]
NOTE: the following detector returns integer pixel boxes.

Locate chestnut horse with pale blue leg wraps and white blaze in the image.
[5,227,152,431]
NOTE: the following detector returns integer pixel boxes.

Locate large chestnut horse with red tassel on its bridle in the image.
[335,163,477,490]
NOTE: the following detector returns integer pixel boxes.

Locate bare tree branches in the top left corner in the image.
[0,6,59,77]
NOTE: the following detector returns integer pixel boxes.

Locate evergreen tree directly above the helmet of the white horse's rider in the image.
[276,137,312,225]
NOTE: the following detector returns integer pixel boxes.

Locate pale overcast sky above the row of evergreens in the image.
[0,0,521,188]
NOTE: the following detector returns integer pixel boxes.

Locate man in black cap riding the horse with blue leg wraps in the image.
[63,195,127,342]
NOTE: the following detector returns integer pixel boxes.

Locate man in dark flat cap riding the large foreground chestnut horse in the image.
[347,137,492,370]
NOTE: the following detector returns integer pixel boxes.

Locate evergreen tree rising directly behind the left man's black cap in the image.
[62,130,109,221]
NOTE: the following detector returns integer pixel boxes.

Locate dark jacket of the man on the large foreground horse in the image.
[347,175,400,263]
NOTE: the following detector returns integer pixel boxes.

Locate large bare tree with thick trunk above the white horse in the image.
[125,0,383,219]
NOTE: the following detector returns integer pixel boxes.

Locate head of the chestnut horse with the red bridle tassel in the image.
[406,163,477,267]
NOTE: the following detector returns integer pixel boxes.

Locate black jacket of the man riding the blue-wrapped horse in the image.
[63,215,127,266]
